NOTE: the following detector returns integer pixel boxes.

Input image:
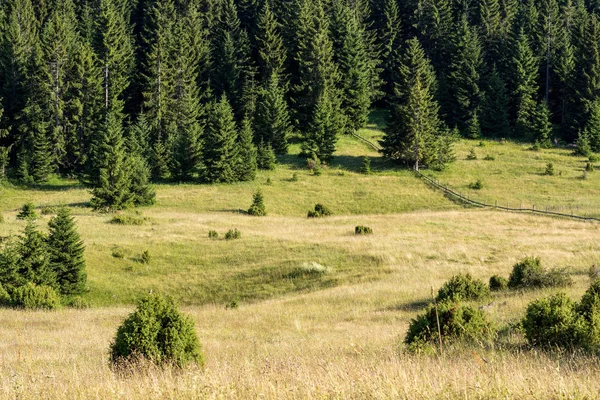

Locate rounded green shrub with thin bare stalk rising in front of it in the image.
[404,301,494,350]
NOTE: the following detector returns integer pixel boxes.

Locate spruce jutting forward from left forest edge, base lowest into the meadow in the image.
[90,112,134,211]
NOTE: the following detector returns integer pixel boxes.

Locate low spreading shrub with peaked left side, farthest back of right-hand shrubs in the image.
[508,257,573,289]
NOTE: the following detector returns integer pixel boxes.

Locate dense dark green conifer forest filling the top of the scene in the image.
[0,0,600,192]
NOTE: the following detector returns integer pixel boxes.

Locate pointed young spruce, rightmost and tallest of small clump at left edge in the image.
[46,207,87,295]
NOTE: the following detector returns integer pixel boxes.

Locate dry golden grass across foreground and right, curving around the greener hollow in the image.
[0,211,600,399]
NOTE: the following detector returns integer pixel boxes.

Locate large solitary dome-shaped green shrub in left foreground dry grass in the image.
[110,294,204,367]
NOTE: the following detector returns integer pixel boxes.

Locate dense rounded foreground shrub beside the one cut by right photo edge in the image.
[522,293,588,347]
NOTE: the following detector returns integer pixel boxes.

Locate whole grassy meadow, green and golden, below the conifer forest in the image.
[0,115,600,399]
